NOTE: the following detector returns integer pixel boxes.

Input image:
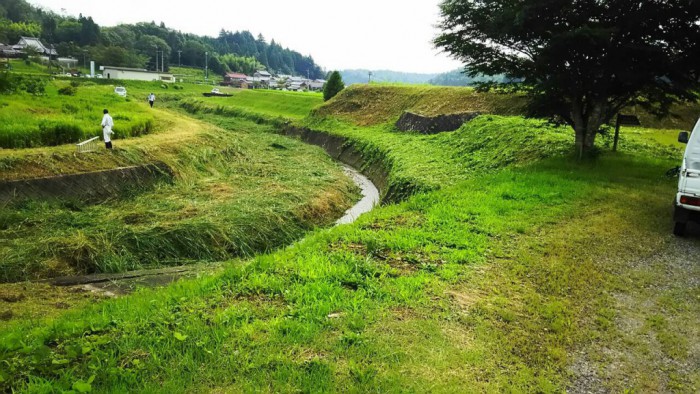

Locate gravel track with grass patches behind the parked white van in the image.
[569,226,700,393]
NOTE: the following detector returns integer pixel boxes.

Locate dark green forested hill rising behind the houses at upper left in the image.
[0,0,324,78]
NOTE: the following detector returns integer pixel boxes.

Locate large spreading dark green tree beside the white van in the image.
[435,0,700,155]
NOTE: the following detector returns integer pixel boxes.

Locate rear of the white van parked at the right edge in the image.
[673,120,700,237]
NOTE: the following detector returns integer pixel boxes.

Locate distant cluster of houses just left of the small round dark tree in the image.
[221,70,326,92]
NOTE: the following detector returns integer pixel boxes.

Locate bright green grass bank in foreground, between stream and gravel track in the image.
[0,83,700,392]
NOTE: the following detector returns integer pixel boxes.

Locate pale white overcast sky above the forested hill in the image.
[29,0,460,73]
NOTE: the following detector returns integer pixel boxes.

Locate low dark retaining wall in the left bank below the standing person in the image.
[0,163,173,204]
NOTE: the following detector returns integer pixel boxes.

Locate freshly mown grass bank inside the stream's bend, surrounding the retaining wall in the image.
[0,114,355,281]
